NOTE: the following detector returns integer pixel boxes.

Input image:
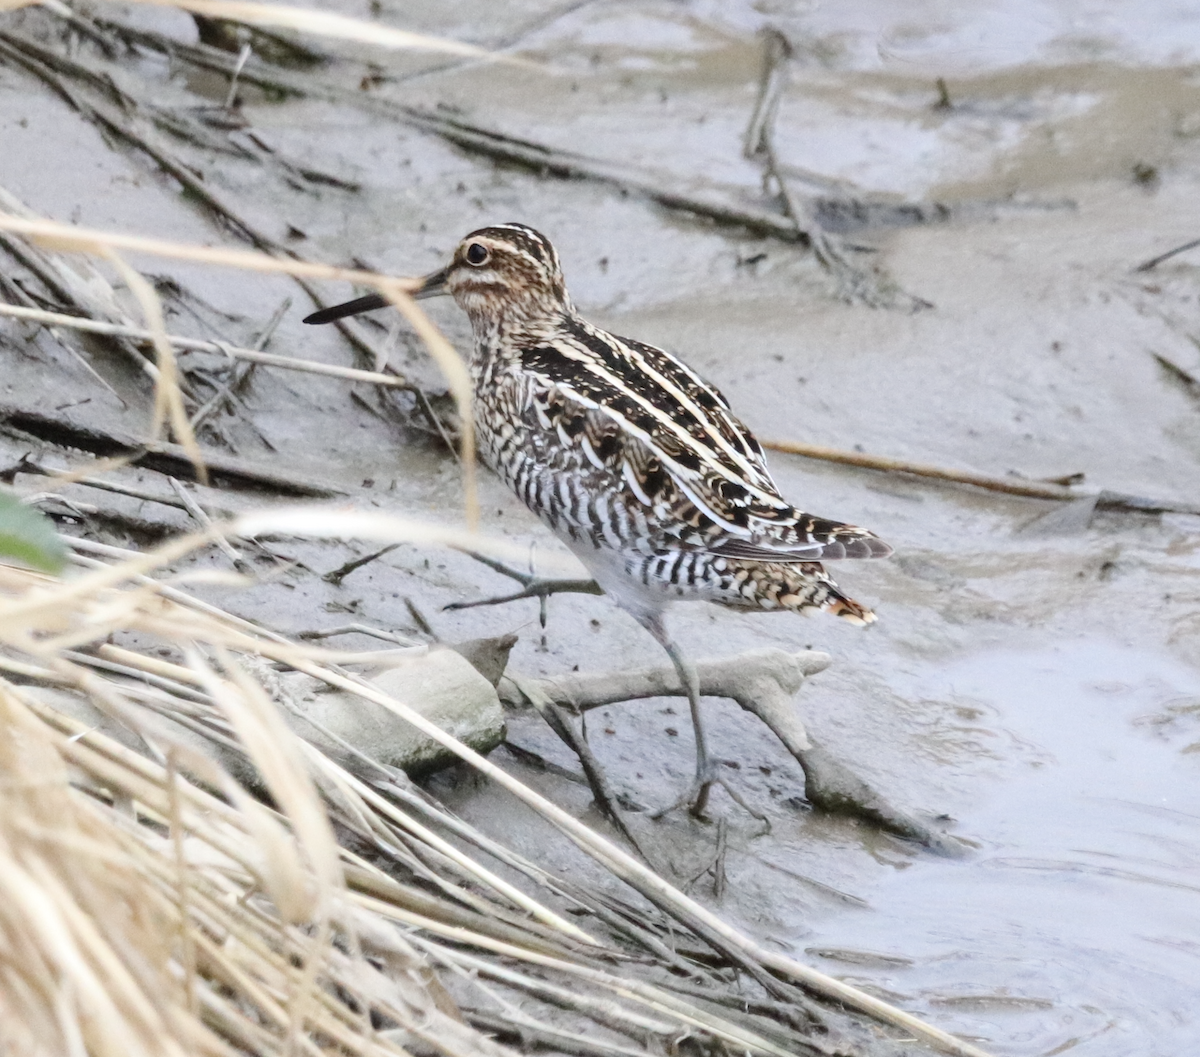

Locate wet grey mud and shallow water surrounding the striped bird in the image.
[0,0,1200,1057]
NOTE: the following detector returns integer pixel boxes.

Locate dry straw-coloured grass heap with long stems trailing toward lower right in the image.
[0,523,993,1055]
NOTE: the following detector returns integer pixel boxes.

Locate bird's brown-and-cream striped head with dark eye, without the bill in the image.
[421,223,571,322]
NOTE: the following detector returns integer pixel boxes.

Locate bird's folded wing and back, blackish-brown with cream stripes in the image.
[517,338,892,561]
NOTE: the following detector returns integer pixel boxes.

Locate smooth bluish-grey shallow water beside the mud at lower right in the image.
[805,636,1200,1055]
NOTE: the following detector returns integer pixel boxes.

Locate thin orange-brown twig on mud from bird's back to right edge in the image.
[762,431,1200,514]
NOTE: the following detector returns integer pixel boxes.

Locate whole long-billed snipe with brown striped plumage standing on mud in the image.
[306,223,892,813]
